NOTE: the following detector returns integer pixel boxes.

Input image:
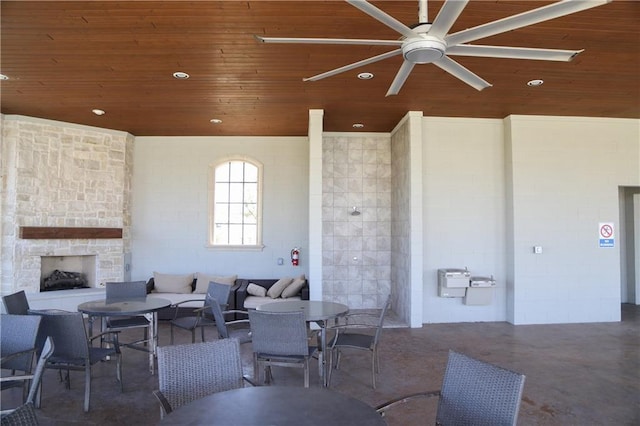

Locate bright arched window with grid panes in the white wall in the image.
[209,158,262,248]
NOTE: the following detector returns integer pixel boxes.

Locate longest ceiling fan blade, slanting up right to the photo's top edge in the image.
[445,0,612,46]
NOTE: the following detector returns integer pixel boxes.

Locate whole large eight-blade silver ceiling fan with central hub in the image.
[256,0,612,96]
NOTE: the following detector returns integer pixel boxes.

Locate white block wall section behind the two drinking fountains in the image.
[422,117,506,323]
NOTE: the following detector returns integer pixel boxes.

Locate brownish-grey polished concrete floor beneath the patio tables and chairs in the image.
[2,305,640,426]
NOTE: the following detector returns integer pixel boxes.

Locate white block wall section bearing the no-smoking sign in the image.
[507,116,640,324]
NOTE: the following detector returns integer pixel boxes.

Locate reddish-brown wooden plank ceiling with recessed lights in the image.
[0,0,640,136]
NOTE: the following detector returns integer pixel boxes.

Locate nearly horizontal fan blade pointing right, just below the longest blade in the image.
[447,44,584,62]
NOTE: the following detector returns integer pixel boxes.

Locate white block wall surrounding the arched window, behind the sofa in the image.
[132,137,313,285]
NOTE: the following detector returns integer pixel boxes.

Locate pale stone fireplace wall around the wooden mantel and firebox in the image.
[0,115,134,294]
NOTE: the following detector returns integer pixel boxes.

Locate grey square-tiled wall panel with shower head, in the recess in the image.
[322,134,391,309]
